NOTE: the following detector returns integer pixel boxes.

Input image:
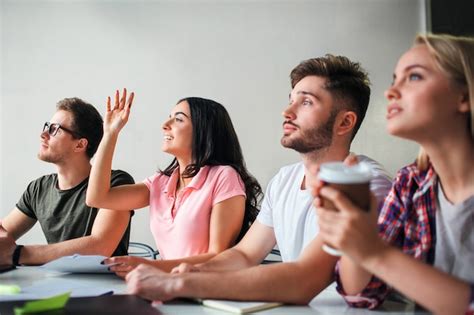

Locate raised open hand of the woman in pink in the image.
[104,88,135,133]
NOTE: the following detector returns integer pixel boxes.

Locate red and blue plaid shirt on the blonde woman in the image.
[336,164,474,312]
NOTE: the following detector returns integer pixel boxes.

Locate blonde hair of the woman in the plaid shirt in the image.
[415,34,474,171]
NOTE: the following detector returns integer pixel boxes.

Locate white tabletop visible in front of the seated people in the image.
[0,267,426,315]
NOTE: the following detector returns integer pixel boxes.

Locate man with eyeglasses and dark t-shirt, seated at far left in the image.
[0,98,134,265]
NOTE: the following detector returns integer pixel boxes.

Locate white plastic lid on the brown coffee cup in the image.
[319,162,372,184]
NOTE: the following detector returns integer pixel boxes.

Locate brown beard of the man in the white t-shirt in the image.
[281,110,337,154]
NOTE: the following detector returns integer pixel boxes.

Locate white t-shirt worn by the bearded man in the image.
[257,155,392,262]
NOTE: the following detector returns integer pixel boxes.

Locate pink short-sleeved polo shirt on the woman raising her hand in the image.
[143,165,245,259]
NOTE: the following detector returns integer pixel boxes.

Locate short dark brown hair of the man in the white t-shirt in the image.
[290,54,370,139]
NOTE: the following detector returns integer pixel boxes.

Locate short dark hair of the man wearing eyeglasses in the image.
[56,97,104,159]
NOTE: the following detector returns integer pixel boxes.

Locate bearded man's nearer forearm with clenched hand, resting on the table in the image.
[126,237,337,304]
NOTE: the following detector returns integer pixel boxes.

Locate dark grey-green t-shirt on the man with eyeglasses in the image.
[16,170,134,256]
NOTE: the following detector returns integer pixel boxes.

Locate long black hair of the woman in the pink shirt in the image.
[162,97,262,242]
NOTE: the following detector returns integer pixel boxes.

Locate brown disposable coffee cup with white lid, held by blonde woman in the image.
[318,162,372,256]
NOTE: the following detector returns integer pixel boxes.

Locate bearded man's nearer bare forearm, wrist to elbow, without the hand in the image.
[178,263,333,304]
